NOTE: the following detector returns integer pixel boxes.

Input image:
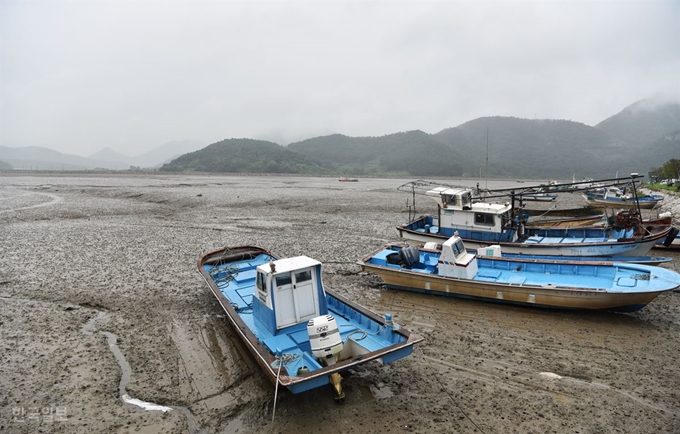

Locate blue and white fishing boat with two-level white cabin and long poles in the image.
[397,181,672,256]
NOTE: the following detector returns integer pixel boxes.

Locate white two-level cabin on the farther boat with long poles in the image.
[425,187,512,233]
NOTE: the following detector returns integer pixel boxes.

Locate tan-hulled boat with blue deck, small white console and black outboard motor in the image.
[358,235,680,312]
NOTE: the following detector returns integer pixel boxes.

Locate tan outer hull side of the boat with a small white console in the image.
[361,262,662,312]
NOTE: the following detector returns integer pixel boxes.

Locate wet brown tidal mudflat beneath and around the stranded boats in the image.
[0,172,680,434]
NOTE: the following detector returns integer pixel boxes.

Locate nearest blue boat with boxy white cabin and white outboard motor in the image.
[198,246,422,400]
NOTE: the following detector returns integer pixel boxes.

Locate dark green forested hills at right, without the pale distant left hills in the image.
[161,103,680,179]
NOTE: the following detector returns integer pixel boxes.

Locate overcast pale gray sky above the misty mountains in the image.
[0,0,680,156]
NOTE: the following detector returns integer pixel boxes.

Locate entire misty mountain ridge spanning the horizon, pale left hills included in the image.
[0,100,680,177]
